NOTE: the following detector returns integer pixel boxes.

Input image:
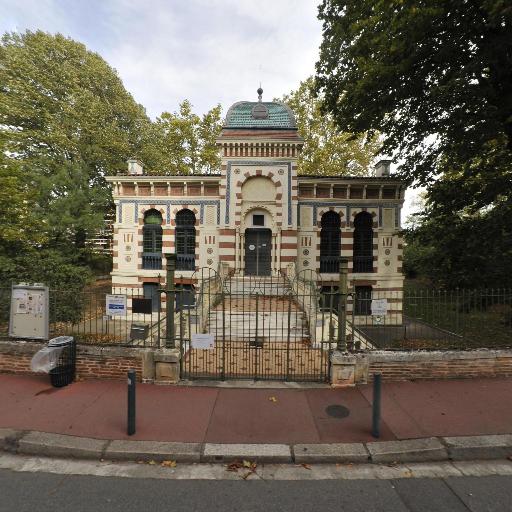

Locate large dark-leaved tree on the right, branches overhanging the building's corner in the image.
[316,0,512,286]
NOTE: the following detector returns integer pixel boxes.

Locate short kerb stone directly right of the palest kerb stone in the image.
[293,443,369,463]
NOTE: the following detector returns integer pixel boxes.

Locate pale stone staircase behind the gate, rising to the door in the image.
[208,276,310,347]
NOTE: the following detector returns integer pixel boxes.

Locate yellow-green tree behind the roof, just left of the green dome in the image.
[155,100,222,175]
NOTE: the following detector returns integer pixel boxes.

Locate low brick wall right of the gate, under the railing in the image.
[367,349,512,381]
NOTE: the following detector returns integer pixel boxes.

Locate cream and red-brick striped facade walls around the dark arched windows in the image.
[108,96,405,324]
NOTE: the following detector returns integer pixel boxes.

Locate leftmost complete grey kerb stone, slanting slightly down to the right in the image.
[18,432,108,459]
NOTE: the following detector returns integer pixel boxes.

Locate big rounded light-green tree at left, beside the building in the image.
[0,31,152,250]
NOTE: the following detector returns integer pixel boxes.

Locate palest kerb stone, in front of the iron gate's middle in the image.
[201,443,292,463]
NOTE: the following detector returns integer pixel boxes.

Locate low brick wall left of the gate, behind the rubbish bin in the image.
[0,341,142,381]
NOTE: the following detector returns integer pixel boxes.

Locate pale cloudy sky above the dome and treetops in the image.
[0,0,420,215]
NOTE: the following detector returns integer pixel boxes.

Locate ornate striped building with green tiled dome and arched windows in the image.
[107,88,405,382]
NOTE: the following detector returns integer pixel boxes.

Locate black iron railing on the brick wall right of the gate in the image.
[323,287,512,350]
